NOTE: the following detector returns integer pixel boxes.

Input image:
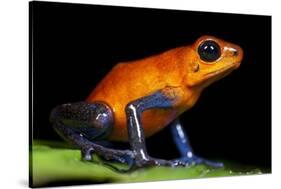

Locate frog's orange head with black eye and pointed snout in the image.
[186,36,243,89]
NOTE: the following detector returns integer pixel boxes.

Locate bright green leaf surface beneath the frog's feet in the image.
[30,141,262,187]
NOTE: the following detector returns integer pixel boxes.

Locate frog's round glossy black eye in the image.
[198,40,221,62]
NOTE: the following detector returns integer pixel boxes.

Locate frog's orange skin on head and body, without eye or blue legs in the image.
[87,36,242,141]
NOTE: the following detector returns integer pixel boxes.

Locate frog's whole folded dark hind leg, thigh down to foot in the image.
[50,102,133,162]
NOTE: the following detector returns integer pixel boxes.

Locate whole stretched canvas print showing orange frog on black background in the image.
[29,1,271,187]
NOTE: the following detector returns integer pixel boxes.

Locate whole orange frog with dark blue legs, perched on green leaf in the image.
[50,35,243,168]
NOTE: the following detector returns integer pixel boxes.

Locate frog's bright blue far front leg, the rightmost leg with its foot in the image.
[170,119,223,167]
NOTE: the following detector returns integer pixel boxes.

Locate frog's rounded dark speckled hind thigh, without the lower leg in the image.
[50,102,113,140]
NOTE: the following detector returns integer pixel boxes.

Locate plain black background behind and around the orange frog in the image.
[30,2,271,168]
